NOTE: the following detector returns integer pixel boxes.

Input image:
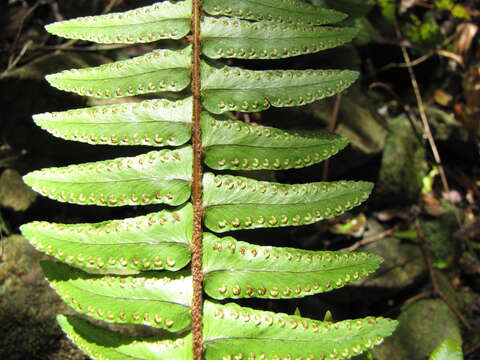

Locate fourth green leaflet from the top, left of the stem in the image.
[23,146,192,206]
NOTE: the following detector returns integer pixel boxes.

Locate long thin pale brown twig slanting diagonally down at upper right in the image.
[395,21,450,192]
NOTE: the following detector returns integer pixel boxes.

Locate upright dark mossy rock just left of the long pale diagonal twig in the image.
[374,117,428,207]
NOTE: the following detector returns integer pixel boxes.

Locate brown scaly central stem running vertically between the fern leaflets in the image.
[192,0,203,360]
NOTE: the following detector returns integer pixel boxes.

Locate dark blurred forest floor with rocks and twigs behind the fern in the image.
[0,0,480,360]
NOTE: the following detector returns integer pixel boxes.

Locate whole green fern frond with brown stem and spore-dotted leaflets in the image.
[21,0,396,360]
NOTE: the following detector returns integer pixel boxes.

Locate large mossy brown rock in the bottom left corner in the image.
[0,235,87,360]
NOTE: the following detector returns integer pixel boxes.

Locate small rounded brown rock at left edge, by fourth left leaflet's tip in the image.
[0,169,37,211]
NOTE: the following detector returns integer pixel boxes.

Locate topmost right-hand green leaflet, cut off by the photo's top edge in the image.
[203,0,346,25]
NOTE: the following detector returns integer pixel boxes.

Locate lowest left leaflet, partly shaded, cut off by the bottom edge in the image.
[57,315,192,360]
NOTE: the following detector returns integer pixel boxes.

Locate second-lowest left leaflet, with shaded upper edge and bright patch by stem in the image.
[42,261,192,332]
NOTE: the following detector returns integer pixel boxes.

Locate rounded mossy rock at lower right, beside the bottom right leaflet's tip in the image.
[373,299,462,360]
